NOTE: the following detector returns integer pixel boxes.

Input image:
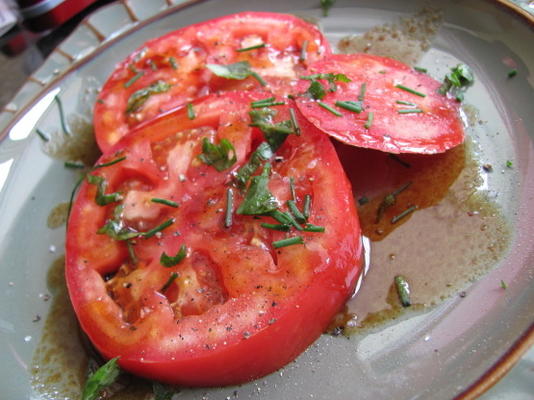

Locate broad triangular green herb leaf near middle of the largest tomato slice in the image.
[237,163,278,215]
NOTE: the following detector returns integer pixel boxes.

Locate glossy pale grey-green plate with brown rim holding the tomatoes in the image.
[0,0,534,400]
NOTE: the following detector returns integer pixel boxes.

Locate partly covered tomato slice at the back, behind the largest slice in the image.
[94,12,331,152]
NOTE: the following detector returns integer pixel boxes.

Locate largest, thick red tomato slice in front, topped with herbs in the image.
[66,92,361,386]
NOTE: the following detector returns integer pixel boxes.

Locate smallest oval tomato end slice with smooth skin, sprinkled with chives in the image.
[297,54,464,154]
